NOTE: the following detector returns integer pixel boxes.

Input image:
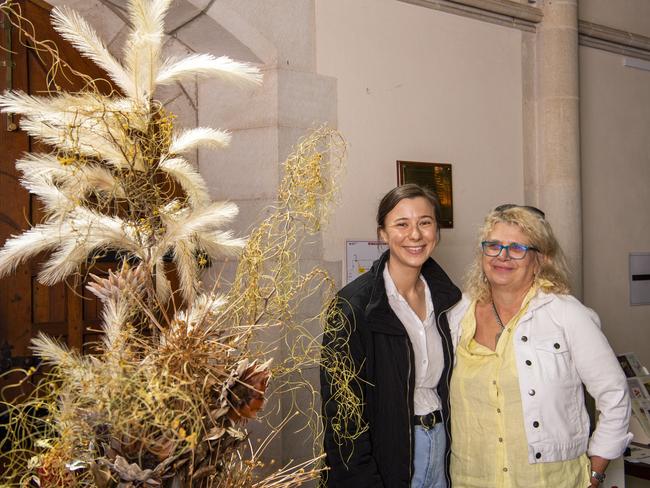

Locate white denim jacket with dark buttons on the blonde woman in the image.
[449,292,632,464]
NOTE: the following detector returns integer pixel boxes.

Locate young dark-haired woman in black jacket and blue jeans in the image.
[321,184,461,488]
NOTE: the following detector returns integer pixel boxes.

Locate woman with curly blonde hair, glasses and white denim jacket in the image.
[450,204,632,488]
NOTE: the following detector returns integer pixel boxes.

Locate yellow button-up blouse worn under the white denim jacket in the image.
[451,287,591,488]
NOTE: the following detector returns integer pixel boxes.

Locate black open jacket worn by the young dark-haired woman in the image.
[321,251,461,488]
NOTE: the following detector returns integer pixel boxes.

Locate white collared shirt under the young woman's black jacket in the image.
[384,266,444,415]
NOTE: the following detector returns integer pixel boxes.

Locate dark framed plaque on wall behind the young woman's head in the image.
[397,161,454,229]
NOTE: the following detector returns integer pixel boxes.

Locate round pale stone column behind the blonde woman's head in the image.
[526,0,582,297]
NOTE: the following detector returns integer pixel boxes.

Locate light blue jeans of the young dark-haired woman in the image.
[411,423,447,488]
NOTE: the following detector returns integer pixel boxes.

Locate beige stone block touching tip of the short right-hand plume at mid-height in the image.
[199,127,279,201]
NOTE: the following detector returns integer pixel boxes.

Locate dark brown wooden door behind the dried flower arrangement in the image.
[0,0,112,378]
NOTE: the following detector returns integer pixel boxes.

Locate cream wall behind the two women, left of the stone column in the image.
[316,0,523,283]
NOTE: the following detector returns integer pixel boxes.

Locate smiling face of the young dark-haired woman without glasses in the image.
[379,197,437,270]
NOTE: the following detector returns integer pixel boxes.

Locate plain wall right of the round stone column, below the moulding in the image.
[580,45,650,367]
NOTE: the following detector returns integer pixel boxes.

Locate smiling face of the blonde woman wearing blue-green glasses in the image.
[483,222,539,292]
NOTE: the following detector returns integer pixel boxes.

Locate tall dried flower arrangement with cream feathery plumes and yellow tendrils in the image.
[0,0,345,488]
